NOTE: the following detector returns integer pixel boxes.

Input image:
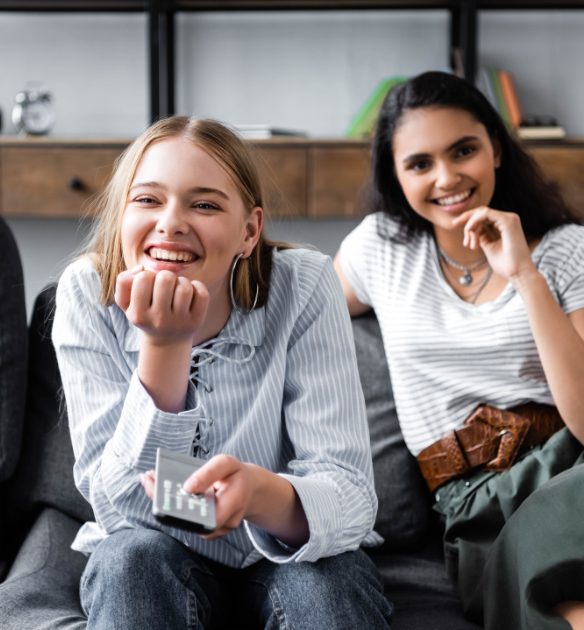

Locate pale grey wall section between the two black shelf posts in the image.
[178,11,448,138]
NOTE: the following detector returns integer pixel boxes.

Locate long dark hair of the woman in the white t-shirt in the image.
[366,72,581,242]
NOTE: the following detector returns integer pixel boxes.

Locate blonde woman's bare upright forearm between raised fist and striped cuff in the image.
[138,335,191,413]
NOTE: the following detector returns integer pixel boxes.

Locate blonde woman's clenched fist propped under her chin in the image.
[115,267,209,343]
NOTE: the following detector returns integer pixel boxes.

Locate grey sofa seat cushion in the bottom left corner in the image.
[0,509,87,630]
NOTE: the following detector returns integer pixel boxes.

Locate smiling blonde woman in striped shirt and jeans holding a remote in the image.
[53,117,392,630]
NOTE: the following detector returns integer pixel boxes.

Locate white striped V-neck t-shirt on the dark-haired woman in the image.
[340,213,584,455]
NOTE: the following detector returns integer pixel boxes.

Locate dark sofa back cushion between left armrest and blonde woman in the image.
[5,285,94,564]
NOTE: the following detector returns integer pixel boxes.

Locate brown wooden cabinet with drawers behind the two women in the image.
[0,137,584,218]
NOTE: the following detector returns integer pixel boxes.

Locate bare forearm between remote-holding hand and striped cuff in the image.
[245,464,310,548]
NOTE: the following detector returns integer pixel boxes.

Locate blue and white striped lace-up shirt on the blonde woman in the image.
[53,250,377,567]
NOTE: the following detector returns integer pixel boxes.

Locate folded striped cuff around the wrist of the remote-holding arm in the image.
[245,475,343,564]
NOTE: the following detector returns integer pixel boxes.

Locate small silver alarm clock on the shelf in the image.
[12,81,57,136]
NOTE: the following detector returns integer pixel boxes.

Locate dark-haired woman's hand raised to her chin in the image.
[453,206,538,284]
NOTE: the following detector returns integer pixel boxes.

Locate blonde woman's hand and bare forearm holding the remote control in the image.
[140,455,309,547]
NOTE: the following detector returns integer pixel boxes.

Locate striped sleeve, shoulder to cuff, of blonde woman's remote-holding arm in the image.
[246,259,377,563]
